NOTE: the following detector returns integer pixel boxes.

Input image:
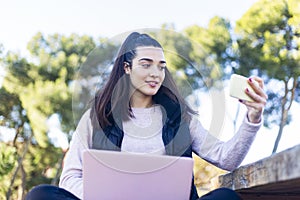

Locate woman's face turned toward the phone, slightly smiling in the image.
[125,46,166,97]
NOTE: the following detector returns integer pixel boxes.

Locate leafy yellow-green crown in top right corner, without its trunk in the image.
[236,0,300,77]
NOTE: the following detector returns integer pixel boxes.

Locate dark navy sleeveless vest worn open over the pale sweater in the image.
[91,94,198,200]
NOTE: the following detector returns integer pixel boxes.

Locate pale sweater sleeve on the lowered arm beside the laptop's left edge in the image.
[59,110,92,199]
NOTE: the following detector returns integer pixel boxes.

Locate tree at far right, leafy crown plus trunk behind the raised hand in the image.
[236,0,300,153]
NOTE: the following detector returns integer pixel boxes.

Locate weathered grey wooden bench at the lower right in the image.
[219,145,300,200]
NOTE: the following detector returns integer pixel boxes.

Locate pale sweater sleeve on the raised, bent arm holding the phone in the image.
[190,117,262,171]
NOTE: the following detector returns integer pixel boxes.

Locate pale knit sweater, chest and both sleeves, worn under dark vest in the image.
[59,106,261,198]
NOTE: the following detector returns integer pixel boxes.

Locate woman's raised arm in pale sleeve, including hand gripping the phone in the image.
[190,76,268,171]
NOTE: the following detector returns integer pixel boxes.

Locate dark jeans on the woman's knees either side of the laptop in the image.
[25,185,241,200]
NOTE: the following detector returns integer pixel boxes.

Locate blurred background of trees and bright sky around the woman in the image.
[0,0,300,199]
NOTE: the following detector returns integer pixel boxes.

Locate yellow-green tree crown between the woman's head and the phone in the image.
[185,16,234,88]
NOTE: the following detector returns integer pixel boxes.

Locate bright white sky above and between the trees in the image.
[0,0,300,164]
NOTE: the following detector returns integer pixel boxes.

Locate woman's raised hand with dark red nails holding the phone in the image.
[240,76,268,123]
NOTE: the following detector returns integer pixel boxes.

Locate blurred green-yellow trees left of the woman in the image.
[0,33,96,199]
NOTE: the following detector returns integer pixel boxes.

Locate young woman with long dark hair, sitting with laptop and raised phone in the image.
[27,32,267,200]
